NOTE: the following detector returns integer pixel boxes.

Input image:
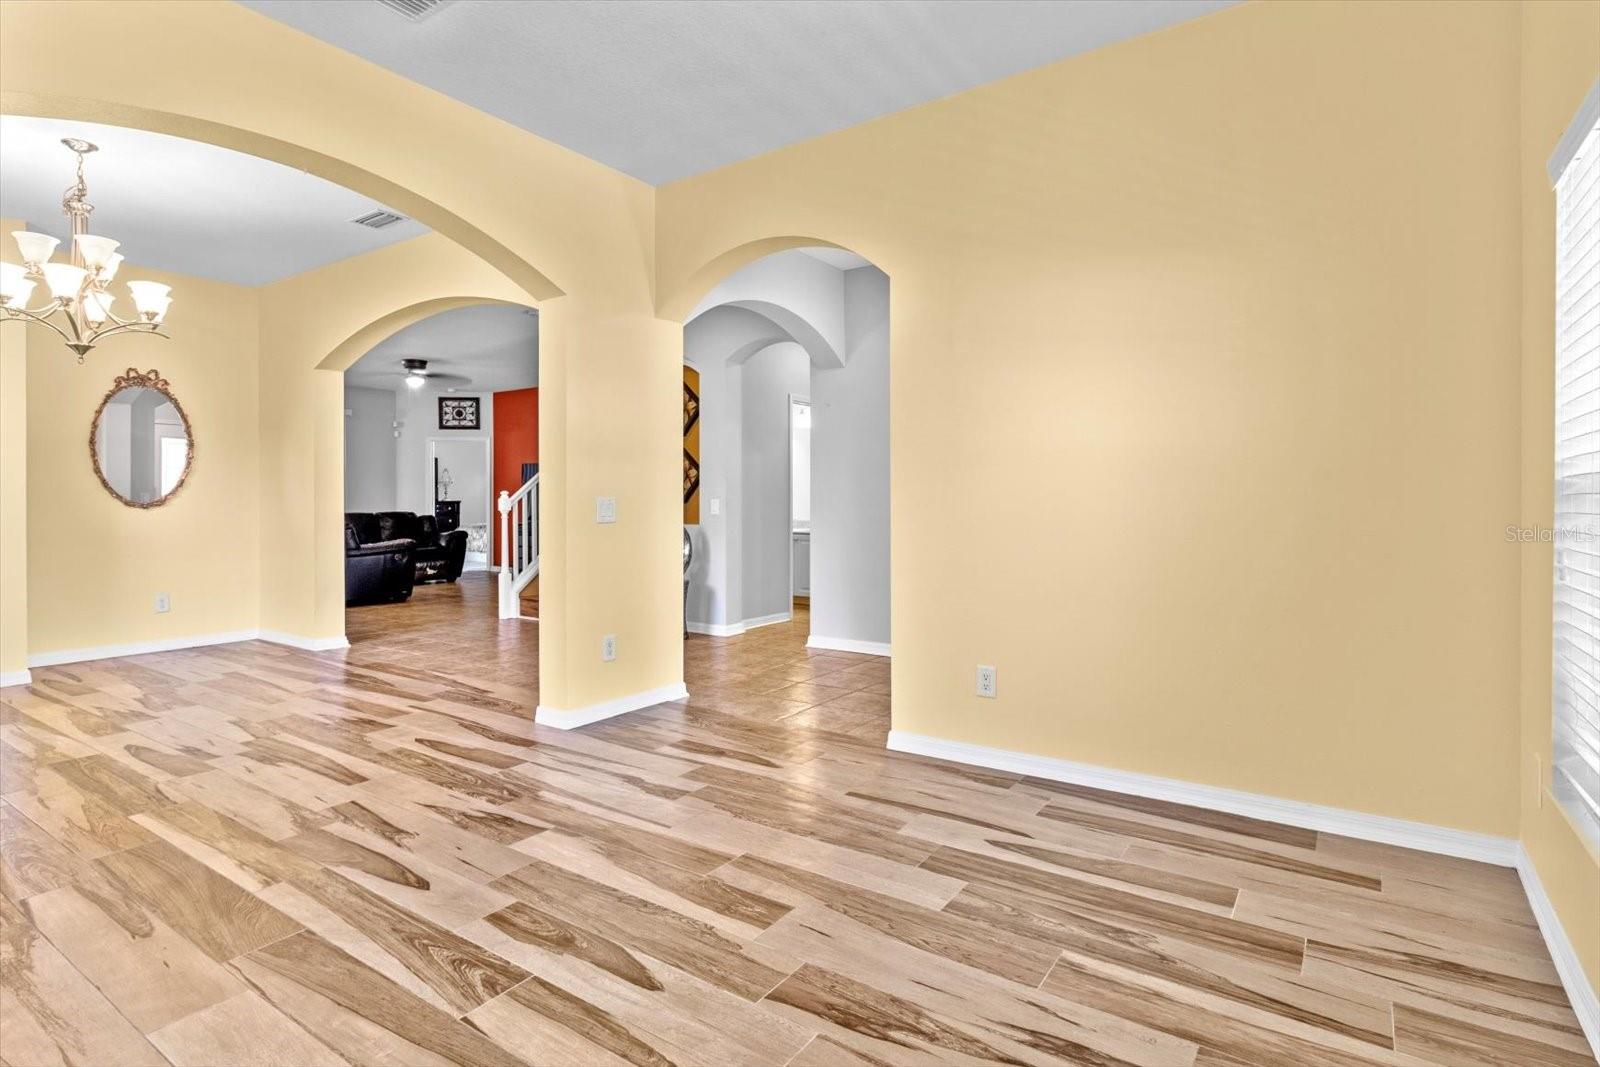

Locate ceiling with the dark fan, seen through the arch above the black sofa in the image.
[344,304,539,394]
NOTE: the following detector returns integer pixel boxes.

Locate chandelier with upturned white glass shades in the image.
[0,138,173,363]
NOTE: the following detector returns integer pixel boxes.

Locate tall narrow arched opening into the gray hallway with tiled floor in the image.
[685,238,890,726]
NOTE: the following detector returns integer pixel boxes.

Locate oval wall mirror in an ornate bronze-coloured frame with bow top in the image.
[90,366,195,507]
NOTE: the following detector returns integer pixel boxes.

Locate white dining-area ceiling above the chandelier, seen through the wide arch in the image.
[0,115,427,286]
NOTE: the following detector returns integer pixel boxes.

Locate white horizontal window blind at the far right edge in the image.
[1550,115,1600,833]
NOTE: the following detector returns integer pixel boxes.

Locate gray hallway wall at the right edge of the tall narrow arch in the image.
[811,267,890,645]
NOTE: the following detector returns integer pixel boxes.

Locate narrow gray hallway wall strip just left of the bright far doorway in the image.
[739,341,811,621]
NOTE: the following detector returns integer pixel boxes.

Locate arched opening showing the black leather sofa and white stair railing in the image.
[333,299,539,704]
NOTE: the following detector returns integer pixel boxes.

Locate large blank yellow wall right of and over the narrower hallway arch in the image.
[658,3,1520,835]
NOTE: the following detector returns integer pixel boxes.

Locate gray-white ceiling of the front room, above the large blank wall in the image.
[240,0,1232,184]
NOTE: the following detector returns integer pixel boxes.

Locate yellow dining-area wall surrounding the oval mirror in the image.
[18,262,261,654]
